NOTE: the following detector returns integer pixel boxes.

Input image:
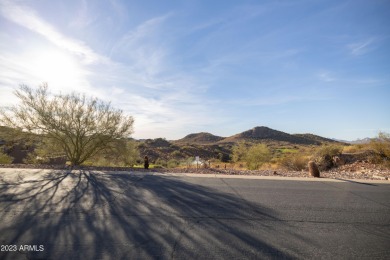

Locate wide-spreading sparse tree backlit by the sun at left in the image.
[0,84,134,165]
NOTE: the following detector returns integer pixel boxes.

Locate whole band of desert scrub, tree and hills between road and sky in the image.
[0,85,390,174]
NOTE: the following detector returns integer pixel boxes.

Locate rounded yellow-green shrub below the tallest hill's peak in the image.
[243,144,272,170]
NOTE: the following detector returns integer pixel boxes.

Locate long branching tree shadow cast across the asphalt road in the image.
[0,170,315,259]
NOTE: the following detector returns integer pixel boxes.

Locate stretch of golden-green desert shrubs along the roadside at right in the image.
[227,133,390,171]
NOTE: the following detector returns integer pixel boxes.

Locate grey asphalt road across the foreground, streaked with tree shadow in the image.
[0,169,390,259]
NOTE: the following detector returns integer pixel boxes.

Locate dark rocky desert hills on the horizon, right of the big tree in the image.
[139,126,348,161]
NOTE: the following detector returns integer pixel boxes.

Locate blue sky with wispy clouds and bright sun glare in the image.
[0,0,390,140]
